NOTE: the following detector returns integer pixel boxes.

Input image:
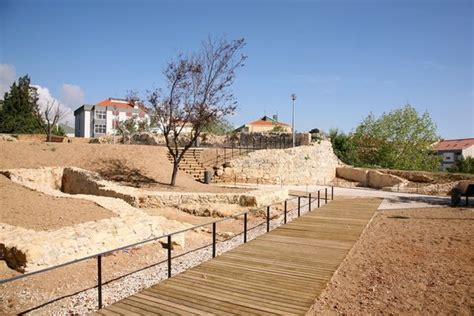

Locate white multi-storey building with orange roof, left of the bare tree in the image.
[74,98,150,138]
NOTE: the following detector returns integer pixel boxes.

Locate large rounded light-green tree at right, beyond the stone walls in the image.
[352,104,440,171]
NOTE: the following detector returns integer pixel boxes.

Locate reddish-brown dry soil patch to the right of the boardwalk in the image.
[309,208,474,315]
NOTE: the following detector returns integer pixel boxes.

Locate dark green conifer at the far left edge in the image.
[0,75,43,134]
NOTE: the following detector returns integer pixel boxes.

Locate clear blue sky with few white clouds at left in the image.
[0,0,474,139]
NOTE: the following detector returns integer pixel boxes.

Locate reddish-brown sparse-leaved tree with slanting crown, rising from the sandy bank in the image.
[147,38,247,186]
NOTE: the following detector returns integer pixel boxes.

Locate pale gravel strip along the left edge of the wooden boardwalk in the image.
[25,198,314,315]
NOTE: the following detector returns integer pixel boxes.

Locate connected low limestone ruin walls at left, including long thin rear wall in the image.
[0,167,288,272]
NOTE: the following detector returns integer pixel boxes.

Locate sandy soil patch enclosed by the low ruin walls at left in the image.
[0,175,116,230]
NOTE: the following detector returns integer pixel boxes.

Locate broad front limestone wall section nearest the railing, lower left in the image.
[0,215,191,272]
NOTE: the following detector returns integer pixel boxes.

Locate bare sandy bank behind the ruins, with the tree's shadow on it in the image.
[0,141,238,192]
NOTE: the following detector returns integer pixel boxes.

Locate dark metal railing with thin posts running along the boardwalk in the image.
[0,187,334,314]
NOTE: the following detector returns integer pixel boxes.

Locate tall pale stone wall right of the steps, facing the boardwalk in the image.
[217,140,340,185]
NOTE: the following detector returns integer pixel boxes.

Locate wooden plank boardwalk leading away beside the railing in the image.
[97,198,381,315]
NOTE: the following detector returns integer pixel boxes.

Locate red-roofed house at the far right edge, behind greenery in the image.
[433,138,474,171]
